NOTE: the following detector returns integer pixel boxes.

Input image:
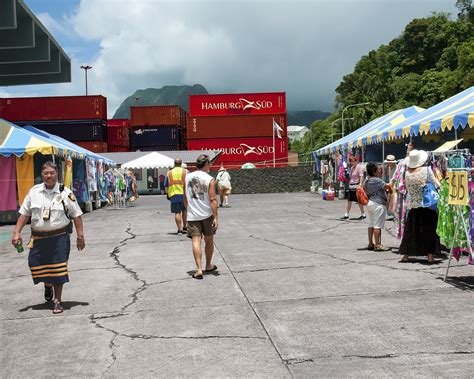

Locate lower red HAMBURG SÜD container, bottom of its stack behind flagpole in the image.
[188,137,288,162]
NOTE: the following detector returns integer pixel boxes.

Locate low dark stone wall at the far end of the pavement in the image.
[209,165,313,194]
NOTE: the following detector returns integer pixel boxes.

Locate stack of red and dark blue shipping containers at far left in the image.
[0,96,107,153]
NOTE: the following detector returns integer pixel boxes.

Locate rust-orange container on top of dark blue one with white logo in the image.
[130,105,186,127]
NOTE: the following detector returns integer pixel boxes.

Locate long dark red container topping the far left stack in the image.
[0,95,107,121]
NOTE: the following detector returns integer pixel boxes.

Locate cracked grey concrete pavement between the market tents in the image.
[0,193,474,378]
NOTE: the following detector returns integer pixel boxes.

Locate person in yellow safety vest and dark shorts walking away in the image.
[165,158,187,236]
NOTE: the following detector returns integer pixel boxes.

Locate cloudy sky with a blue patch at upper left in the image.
[0,0,456,117]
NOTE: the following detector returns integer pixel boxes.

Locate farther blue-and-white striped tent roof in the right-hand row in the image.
[313,106,424,155]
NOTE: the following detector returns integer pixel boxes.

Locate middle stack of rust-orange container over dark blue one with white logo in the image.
[130,105,186,151]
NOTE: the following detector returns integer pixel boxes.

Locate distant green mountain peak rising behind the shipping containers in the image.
[112,84,208,118]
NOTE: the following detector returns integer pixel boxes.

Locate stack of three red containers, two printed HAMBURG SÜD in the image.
[187,92,288,167]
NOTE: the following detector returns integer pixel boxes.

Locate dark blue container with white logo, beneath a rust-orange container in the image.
[130,126,181,148]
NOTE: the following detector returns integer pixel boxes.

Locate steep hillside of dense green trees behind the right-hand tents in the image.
[292,0,474,157]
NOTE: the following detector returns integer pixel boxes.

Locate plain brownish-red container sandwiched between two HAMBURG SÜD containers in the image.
[187,114,286,140]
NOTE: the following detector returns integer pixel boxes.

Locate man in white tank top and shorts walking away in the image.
[184,154,218,279]
